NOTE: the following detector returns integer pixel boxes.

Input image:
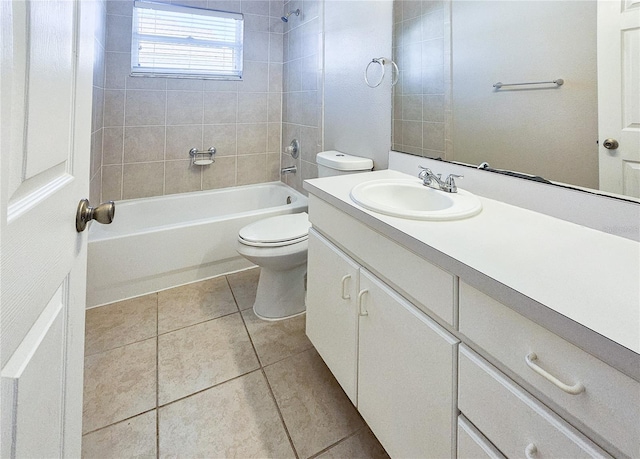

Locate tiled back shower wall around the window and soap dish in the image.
[101,0,284,201]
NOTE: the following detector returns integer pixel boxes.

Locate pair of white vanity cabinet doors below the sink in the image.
[307,230,458,458]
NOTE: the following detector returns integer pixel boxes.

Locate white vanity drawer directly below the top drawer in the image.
[458,345,610,458]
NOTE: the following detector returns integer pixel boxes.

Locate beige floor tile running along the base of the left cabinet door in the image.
[265,349,364,458]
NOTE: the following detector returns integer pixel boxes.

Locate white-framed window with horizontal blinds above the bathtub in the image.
[131,0,244,80]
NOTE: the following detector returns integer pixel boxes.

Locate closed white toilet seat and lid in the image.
[238,212,311,247]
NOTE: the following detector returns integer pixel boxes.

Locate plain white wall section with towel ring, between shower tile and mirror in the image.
[324,0,393,169]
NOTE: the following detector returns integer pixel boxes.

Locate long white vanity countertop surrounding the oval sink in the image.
[305,170,640,354]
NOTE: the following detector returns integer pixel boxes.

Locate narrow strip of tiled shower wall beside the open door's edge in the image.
[89,0,107,205]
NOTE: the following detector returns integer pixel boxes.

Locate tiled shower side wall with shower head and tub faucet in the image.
[282,0,323,191]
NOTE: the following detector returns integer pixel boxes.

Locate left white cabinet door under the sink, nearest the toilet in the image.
[307,229,359,405]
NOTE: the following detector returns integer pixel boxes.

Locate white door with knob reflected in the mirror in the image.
[598,0,640,198]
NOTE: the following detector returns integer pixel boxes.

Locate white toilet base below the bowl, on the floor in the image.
[253,263,307,320]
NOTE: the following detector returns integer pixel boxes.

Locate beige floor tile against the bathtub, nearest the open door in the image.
[85,293,157,355]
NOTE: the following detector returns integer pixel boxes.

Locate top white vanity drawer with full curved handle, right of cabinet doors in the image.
[459,282,640,457]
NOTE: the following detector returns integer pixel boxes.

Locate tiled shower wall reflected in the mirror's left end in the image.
[392,0,452,159]
